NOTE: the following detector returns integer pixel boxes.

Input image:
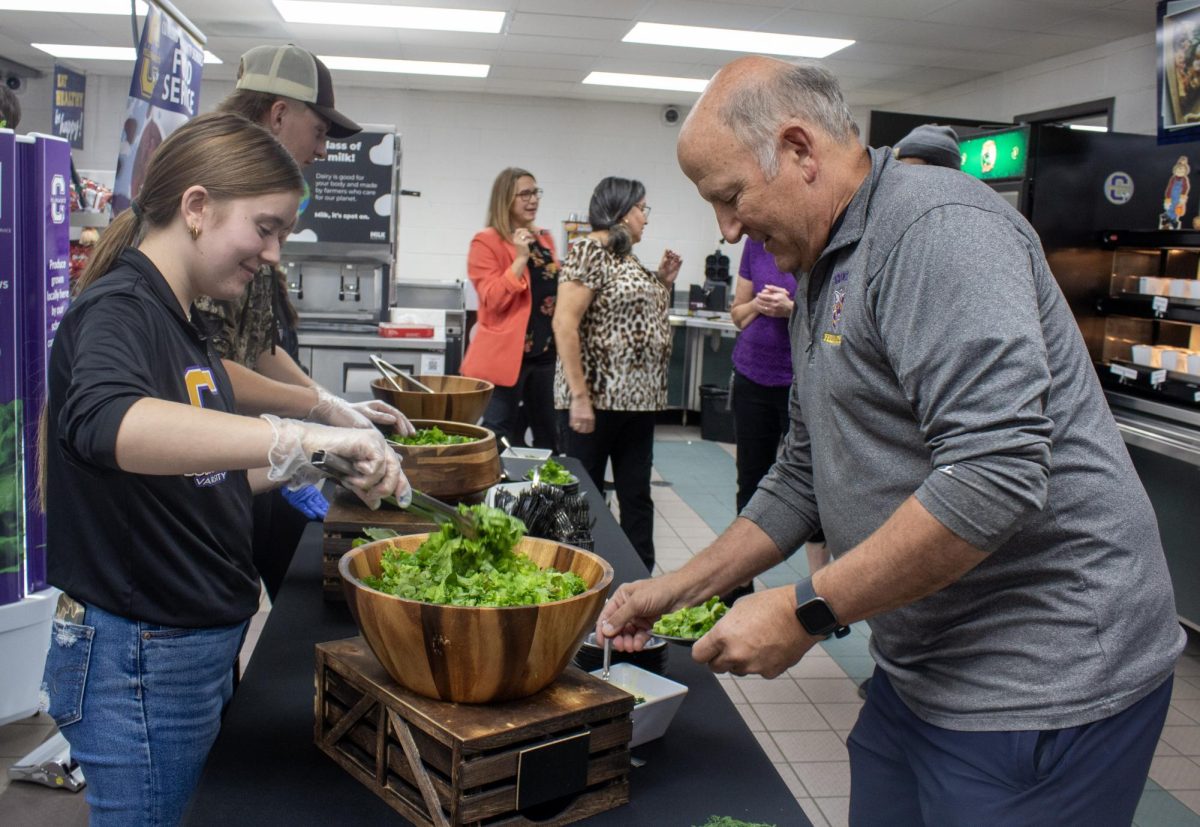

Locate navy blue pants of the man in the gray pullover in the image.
[846,669,1174,827]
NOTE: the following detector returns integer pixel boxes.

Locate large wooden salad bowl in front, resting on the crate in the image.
[337,534,613,703]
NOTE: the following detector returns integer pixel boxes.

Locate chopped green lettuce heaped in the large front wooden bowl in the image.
[364,505,588,606]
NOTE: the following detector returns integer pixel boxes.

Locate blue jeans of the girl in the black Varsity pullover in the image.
[43,606,247,827]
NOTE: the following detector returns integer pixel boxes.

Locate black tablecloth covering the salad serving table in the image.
[184,459,810,827]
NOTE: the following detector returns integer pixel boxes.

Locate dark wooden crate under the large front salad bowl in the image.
[314,637,634,827]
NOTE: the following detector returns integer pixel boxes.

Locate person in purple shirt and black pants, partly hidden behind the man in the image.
[725,238,826,603]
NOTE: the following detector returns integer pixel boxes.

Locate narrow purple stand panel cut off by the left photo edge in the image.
[0,130,25,605]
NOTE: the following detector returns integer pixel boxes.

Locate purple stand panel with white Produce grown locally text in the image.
[17,133,71,593]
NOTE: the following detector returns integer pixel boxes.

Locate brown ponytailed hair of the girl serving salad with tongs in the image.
[76,112,304,292]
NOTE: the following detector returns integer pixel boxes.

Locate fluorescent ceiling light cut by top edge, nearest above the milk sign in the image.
[274,0,504,35]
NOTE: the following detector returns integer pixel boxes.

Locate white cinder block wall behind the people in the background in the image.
[9,32,1156,284]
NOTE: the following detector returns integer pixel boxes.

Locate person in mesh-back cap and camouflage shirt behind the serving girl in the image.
[197,43,413,599]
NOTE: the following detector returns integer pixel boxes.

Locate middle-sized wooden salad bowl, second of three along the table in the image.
[389,419,500,501]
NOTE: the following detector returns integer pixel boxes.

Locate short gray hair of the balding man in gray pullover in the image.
[719,64,858,178]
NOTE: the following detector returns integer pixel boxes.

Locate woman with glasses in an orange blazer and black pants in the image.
[462,167,558,449]
